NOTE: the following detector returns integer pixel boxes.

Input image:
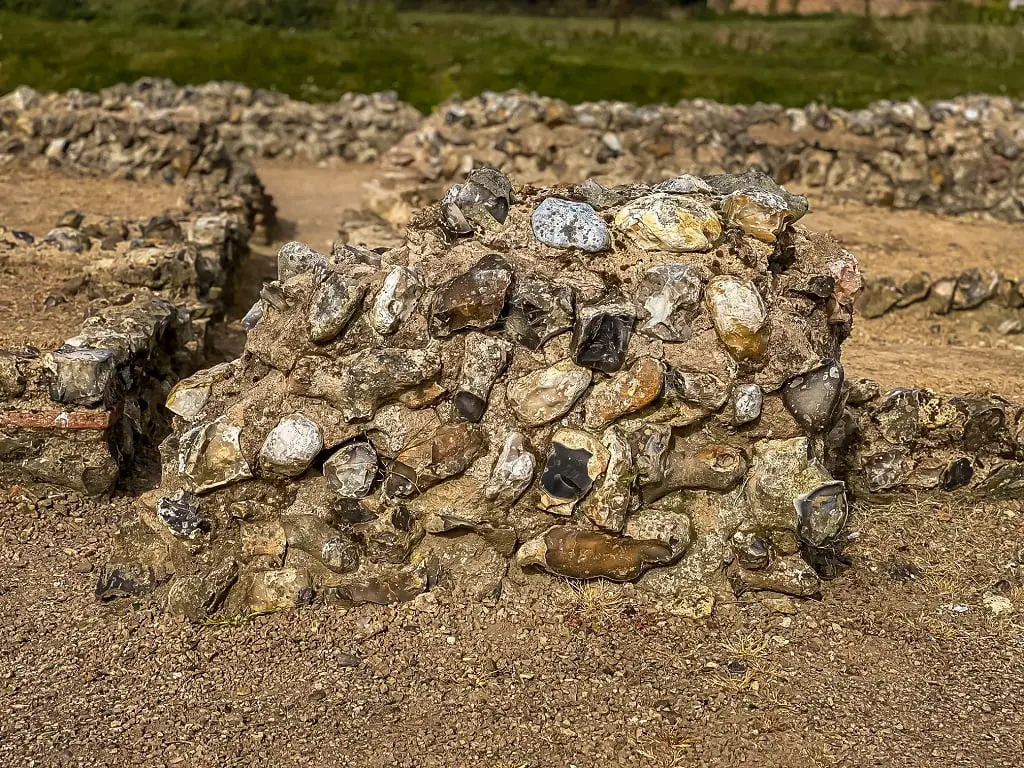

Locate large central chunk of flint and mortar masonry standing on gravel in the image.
[96,169,860,621]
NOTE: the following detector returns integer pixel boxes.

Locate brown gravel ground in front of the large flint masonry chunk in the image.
[0,483,1024,768]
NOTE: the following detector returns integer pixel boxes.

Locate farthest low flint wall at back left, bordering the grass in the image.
[2,78,422,163]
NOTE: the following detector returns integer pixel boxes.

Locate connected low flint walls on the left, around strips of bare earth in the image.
[0,102,274,495]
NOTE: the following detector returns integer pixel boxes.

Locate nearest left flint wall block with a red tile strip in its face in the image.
[0,289,202,495]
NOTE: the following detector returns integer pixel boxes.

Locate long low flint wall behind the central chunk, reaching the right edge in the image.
[371,91,1024,227]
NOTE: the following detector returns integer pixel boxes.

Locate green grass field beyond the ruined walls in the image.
[0,12,1024,111]
